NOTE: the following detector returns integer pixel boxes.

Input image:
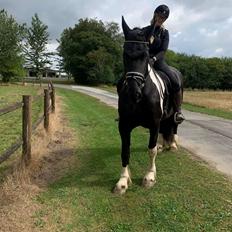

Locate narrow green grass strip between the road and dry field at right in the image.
[183,103,232,120]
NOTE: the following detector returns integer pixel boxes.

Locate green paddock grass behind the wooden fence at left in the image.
[0,85,43,182]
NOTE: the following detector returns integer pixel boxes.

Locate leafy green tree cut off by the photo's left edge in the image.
[0,10,25,82]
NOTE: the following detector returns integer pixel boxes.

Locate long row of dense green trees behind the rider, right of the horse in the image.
[166,51,232,90]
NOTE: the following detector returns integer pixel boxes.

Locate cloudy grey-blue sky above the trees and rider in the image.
[0,0,232,57]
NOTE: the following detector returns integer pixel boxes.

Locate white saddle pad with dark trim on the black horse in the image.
[148,64,165,113]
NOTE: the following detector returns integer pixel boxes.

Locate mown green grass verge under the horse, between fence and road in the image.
[34,90,232,232]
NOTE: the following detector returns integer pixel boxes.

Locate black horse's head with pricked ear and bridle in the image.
[122,17,149,103]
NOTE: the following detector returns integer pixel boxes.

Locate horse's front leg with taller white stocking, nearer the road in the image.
[142,129,158,188]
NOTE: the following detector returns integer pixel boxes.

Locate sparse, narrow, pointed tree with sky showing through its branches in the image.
[24,14,52,77]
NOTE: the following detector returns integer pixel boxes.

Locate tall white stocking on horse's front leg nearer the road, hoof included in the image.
[143,146,157,188]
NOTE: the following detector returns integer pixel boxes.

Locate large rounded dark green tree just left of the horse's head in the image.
[58,19,122,84]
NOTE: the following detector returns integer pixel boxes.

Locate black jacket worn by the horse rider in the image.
[142,25,169,60]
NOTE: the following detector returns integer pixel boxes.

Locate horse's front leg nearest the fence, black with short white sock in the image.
[113,122,132,194]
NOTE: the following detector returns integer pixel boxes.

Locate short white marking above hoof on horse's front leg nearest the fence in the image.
[113,166,132,194]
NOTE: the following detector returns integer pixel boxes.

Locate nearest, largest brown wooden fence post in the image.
[22,95,32,165]
